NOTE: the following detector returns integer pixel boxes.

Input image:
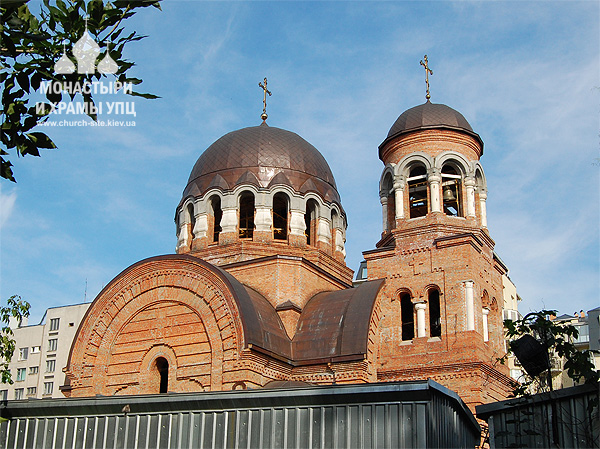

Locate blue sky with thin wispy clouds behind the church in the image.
[0,0,600,322]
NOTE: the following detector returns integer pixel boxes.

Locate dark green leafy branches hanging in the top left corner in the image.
[0,0,160,181]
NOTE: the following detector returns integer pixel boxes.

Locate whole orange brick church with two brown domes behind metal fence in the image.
[61,80,512,408]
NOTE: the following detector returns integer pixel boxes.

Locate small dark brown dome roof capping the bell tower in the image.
[379,100,483,149]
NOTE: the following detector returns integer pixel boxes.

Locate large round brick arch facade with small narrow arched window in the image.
[66,256,245,396]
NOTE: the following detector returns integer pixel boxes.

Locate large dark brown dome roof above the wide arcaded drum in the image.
[183,122,340,204]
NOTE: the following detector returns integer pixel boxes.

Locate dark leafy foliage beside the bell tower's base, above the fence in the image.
[502,310,600,396]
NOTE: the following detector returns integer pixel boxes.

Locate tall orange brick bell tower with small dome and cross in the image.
[363,58,511,404]
